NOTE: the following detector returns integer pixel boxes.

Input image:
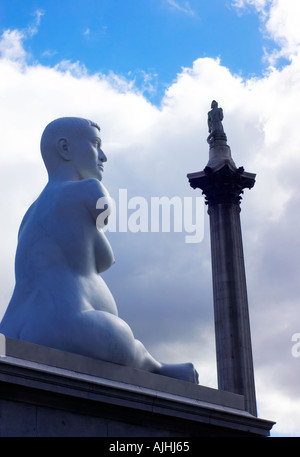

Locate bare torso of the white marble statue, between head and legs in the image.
[0,178,117,337]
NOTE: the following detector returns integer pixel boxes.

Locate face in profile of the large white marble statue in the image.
[70,127,107,181]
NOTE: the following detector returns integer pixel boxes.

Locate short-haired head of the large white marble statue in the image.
[41,117,107,180]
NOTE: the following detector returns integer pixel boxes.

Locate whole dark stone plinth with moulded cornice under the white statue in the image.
[0,335,273,437]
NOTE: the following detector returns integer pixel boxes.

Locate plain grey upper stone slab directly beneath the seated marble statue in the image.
[0,334,245,410]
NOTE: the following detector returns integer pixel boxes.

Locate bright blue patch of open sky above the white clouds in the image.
[0,0,274,103]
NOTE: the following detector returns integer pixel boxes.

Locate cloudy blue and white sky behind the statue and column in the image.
[0,0,300,436]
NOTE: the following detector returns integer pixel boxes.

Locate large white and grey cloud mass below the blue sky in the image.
[0,0,300,436]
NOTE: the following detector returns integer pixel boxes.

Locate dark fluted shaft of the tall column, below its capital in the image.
[208,203,257,415]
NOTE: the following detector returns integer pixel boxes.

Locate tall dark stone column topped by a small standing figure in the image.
[187,100,257,416]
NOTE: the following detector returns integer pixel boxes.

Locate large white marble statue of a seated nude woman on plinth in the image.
[0,118,198,383]
